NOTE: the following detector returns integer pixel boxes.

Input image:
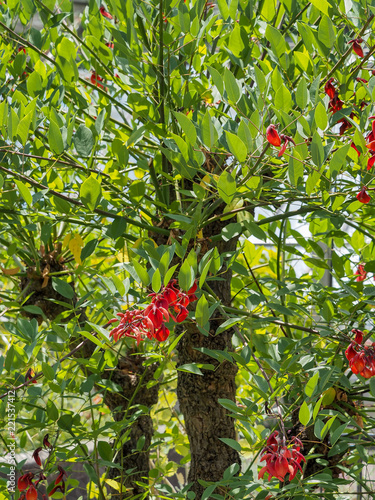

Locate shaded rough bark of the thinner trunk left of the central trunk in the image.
[102,353,159,500]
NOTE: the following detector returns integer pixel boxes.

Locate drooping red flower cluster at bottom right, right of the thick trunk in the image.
[258,431,306,481]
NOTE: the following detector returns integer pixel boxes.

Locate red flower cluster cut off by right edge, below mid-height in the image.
[345,329,375,378]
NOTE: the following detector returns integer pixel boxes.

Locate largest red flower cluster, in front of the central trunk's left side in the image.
[109,280,197,344]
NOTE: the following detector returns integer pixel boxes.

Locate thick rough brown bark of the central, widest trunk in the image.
[177,217,240,499]
